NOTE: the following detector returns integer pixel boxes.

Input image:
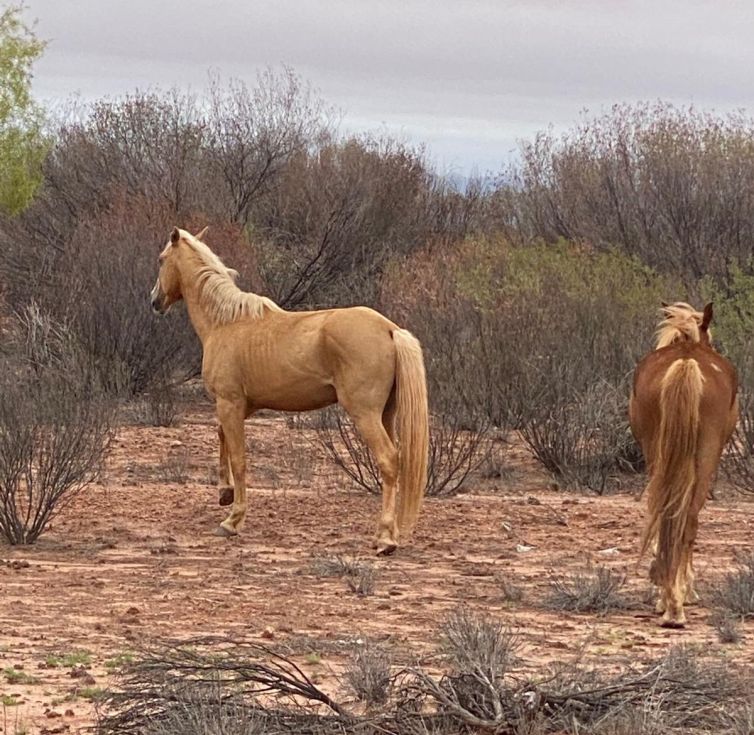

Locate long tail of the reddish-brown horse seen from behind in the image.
[641,359,704,585]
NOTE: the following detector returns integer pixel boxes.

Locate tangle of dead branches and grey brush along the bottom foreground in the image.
[97,636,752,735]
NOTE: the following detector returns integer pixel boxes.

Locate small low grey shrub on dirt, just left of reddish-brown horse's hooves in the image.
[545,566,628,615]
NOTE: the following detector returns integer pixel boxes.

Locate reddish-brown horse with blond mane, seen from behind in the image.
[629,303,738,628]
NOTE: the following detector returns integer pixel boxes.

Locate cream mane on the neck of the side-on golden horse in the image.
[181,231,282,324]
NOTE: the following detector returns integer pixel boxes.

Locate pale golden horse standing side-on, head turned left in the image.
[151,227,429,554]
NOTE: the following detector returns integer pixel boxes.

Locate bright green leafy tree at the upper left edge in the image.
[0,5,47,215]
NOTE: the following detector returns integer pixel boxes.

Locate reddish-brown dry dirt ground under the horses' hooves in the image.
[0,409,754,735]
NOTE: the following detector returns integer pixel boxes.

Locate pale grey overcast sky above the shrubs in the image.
[22,0,754,173]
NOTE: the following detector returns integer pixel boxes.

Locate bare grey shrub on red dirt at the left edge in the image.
[0,309,114,544]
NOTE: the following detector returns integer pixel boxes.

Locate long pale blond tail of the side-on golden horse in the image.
[393,329,429,534]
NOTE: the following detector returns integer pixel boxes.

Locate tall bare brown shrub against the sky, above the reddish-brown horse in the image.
[496,103,754,283]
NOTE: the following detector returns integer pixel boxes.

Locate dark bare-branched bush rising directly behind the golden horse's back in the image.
[252,137,436,308]
